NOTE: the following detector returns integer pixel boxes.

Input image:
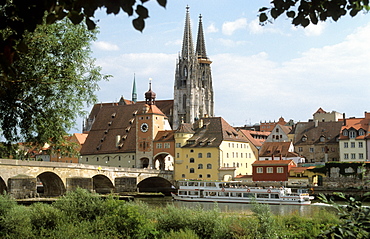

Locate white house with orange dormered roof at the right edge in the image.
[339,112,370,162]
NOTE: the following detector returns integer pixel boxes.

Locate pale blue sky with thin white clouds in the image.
[78,0,370,131]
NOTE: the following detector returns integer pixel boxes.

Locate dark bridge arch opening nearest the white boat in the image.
[137,177,174,195]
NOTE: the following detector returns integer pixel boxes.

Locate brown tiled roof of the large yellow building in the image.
[183,117,248,148]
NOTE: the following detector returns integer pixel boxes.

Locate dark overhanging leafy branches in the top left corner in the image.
[0,0,167,77]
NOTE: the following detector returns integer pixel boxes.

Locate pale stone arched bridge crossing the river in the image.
[0,159,174,198]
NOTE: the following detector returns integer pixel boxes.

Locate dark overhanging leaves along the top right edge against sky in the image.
[259,0,370,27]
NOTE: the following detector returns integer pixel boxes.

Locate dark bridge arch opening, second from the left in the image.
[37,172,66,197]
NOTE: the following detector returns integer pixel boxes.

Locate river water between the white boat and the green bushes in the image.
[135,197,332,217]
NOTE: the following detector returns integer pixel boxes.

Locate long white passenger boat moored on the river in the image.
[171,180,314,205]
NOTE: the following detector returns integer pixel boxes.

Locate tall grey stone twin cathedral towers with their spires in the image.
[173,7,214,130]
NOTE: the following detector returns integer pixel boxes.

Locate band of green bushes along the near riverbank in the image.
[0,189,369,239]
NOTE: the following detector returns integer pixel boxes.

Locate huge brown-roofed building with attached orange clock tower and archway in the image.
[80,83,174,169]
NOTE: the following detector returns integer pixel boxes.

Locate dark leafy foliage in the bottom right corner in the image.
[320,193,370,239]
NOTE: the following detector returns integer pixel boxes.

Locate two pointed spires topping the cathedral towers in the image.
[181,6,207,59]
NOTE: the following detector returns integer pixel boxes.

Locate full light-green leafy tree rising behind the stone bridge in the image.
[0,20,108,153]
